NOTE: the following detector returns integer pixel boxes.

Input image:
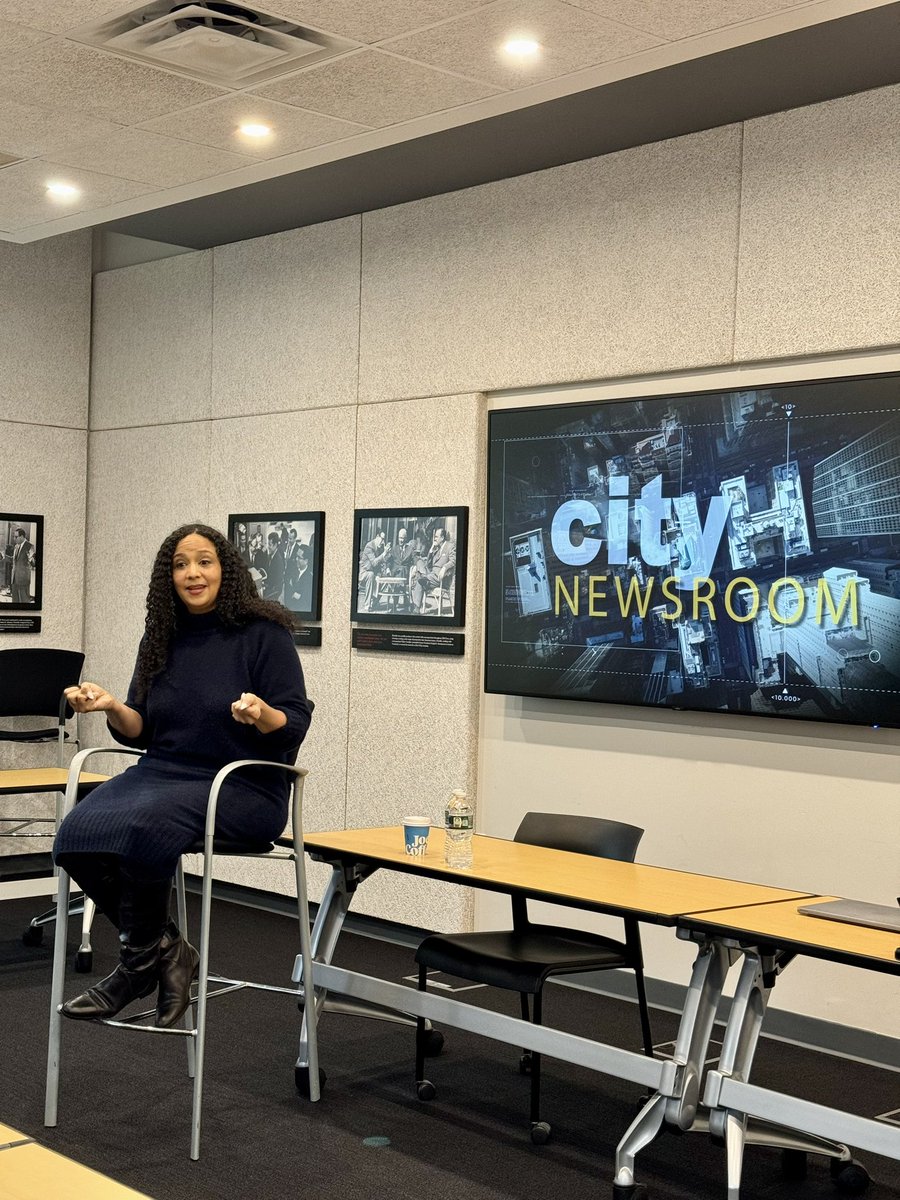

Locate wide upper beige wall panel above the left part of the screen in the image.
[360,126,740,401]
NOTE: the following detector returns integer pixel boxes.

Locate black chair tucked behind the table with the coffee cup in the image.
[415,812,653,1145]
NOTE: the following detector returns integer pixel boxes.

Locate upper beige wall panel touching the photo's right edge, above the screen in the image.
[734,86,900,360]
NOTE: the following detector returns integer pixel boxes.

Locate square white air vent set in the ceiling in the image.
[67,0,354,88]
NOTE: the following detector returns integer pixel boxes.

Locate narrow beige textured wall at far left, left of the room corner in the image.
[0,233,91,854]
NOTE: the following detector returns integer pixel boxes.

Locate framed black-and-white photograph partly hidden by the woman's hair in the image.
[228,512,325,620]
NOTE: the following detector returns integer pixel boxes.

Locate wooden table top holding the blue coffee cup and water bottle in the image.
[304,826,809,924]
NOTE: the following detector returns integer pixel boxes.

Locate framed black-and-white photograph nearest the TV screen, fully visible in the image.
[350,508,469,625]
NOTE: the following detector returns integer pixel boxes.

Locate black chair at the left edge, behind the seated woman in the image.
[0,647,84,946]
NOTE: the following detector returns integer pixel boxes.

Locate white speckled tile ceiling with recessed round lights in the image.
[0,0,883,238]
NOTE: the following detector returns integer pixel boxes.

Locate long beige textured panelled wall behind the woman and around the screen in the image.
[86,88,900,936]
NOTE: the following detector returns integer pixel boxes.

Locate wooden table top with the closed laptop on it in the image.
[680,896,900,974]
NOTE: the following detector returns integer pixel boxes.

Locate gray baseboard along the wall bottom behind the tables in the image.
[192,875,900,1072]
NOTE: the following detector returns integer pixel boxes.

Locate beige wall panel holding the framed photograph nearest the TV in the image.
[347,396,485,929]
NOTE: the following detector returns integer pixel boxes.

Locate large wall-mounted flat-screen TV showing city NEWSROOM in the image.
[485,374,900,726]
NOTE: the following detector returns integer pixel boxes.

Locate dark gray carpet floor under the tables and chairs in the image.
[0,901,900,1200]
